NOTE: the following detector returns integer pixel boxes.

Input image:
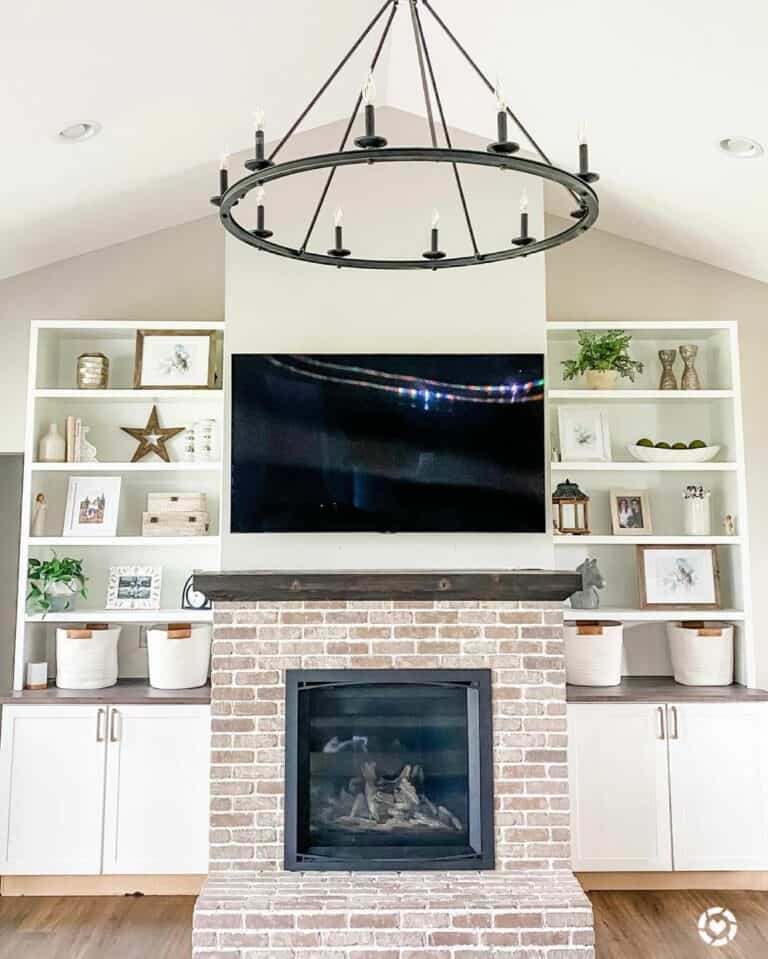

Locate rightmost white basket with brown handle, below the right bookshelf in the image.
[667,623,733,686]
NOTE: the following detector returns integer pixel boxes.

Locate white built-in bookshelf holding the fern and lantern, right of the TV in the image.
[546,321,756,685]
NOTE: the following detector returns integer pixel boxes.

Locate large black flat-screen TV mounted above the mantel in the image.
[231,353,545,533]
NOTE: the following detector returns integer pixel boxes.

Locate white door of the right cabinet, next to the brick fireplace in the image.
[568,703,672,872]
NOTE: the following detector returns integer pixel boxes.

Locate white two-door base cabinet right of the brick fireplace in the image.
[568,703,768,872]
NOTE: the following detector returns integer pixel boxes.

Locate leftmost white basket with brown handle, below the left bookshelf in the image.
[56,626,120,689]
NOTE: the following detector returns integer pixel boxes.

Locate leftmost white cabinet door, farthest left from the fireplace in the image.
[0,704,107,876]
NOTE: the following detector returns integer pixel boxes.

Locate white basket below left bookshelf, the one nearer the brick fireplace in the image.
[147,623,211,689]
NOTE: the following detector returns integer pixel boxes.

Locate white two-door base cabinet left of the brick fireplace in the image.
[0,705,210,875]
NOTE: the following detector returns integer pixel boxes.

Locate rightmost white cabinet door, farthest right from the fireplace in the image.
[668,703,768,870]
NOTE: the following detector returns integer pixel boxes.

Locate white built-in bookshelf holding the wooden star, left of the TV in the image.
[14,320,224,689]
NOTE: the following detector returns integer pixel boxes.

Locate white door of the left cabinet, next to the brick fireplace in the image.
[104,706,210,874]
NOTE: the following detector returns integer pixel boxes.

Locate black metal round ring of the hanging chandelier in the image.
[219,147,600,270]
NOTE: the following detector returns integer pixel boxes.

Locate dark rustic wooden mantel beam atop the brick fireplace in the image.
[195,569,581,603]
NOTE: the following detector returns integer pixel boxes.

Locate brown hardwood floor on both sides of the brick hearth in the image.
[0,891,768,959]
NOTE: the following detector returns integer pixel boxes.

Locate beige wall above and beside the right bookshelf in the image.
[547,217,768,685]
